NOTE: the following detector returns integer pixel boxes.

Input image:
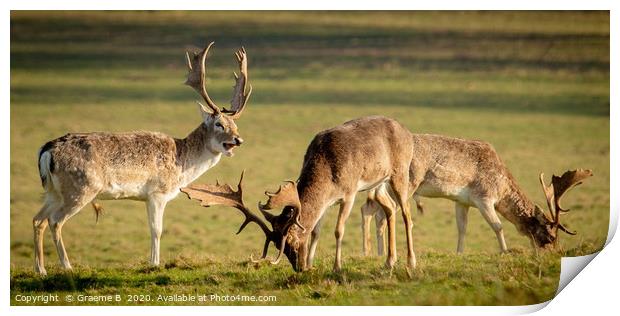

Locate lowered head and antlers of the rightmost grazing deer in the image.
[532,169,592,247]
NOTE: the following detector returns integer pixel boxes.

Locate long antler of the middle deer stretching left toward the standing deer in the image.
[181,170,279,263]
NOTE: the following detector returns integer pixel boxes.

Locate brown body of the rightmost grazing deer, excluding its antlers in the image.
[363,134,557,252]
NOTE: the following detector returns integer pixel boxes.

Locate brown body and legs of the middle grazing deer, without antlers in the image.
[260,116,415,270]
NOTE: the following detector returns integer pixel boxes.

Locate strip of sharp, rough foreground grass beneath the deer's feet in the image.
[11,245,594,305]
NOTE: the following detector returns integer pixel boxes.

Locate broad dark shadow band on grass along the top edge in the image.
[11,13,609,72]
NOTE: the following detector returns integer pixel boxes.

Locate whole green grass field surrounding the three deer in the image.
[10,11,610,305]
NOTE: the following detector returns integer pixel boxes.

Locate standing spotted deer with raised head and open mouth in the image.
[32,42,252,275]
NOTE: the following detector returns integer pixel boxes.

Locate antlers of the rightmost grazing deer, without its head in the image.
[540,169,592,235]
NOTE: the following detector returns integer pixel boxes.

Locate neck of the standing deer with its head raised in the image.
[177,123,222,185]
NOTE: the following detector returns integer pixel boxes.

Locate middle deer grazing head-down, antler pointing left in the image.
[181,116,416,273]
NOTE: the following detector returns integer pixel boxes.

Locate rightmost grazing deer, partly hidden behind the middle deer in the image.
[361,134,593,256]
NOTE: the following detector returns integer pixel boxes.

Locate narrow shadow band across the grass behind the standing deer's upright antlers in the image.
[11,86,610,116]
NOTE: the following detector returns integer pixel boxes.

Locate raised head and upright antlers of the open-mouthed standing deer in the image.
[185,42,252,156]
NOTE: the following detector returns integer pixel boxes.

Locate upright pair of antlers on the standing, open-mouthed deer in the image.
[185,42,252,119]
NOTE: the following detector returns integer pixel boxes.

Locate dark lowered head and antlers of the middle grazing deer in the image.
[181,171,301,264]
